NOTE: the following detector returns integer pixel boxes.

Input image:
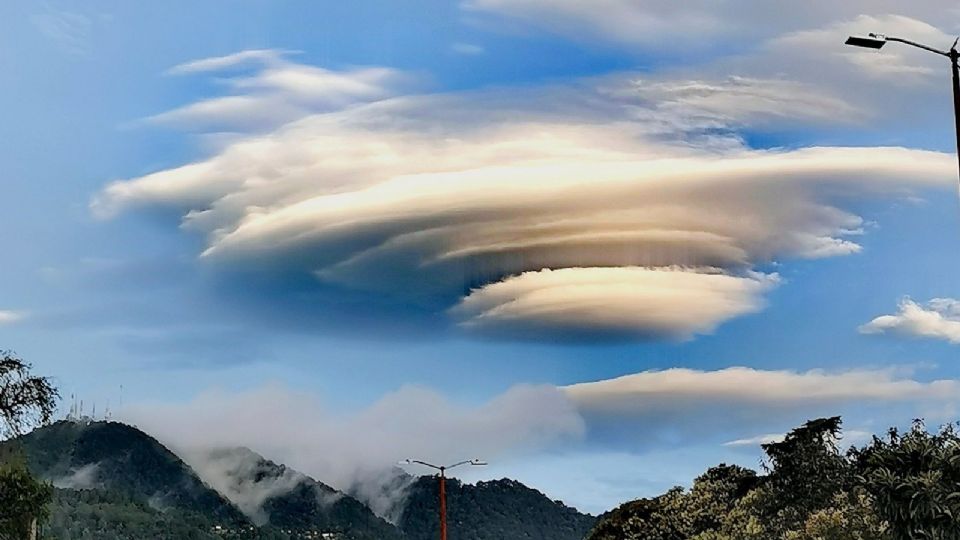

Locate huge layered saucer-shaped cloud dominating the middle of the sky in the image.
[92,52,951,339]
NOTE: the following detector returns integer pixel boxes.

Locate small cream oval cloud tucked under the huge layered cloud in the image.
[453,267,777,339]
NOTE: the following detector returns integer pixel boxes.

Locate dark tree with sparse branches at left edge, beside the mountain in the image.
[0,351,58,540]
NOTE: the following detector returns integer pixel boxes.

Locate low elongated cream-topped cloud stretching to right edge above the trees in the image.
[564,367,960,430]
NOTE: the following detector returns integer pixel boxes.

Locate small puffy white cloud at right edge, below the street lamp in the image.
[860,298,960,344]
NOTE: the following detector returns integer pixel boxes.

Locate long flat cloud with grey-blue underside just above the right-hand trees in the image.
[563,367,960,452]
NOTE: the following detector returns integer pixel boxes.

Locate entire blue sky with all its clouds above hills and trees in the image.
[0,0,960,513]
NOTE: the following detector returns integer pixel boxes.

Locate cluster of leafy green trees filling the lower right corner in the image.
[589,418,960,540]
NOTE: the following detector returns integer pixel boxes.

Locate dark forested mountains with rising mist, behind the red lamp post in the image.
[0,421,595,540]
